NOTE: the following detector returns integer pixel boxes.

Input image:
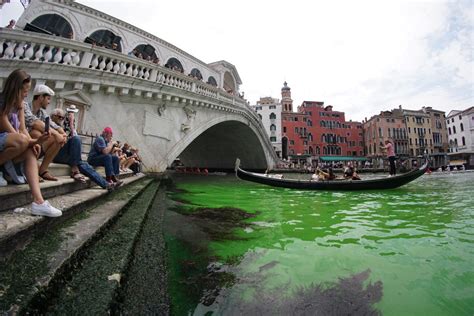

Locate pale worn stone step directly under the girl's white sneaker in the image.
[0,175,145,261]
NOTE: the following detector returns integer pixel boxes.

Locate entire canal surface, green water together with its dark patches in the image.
[164,172,474,315]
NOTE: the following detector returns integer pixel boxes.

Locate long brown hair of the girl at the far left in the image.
[0,69,31,115]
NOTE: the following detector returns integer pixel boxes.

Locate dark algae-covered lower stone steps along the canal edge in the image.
[0,178,159,314]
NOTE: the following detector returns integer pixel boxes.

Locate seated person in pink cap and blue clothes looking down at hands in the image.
[87,127,123,186]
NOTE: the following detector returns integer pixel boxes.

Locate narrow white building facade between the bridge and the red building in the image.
[252,97,282,158]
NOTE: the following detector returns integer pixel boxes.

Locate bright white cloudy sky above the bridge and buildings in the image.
[0,0,474,121]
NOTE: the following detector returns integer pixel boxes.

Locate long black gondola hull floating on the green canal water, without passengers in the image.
[235,158,428,191]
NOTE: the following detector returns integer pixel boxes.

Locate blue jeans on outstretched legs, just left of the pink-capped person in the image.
[53,136,107,189]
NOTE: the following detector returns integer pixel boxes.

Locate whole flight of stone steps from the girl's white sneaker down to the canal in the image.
[0,176,159,314]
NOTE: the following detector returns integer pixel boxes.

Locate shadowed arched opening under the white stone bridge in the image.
[165,115,273,169]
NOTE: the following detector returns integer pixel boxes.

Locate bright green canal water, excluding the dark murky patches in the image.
[168,172,474,315]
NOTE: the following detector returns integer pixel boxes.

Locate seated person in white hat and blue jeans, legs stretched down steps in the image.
[51,106,116,191]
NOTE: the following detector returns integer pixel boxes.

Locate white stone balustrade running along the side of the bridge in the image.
[0,29,246,108]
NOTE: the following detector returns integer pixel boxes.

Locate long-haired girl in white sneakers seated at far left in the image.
[0,69,62,217]
